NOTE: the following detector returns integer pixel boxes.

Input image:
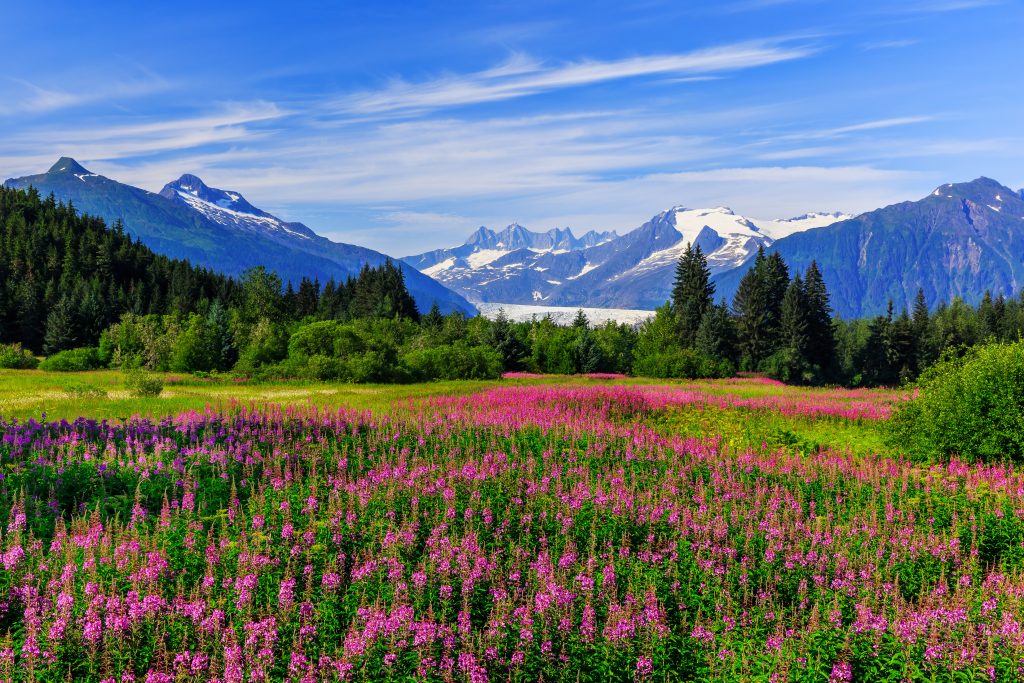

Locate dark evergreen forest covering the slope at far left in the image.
[0,187,237,354]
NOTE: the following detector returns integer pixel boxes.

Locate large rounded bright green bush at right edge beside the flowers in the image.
[890,341,1024,461]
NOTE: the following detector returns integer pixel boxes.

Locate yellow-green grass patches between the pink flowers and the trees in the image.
[0,370,886,454]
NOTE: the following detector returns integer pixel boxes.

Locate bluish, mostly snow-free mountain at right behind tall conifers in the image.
[715,177,1024,317]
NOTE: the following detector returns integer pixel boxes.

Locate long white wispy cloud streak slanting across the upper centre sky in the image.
[337,41,818,115]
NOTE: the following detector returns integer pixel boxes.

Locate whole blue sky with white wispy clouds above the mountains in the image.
[0,0,1024,256]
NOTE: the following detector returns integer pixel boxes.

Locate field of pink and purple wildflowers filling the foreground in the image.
[0,376,1024,683]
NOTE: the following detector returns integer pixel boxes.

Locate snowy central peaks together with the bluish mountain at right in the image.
[404,177,1024,318]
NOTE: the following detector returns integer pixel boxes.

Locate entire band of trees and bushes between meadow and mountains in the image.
[0,188,1024,385]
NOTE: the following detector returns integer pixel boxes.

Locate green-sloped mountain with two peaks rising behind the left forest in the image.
[4,157,476,314]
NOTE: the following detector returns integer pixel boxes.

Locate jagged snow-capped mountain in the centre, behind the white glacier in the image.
[404,207,849,308]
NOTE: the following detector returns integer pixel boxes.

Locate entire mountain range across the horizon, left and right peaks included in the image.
[4,157,1024,317]
